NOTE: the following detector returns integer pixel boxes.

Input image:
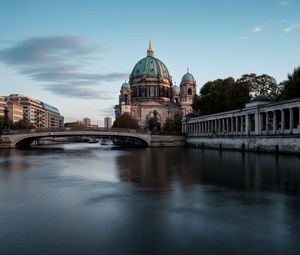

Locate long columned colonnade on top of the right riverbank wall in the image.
[182,98,300,136]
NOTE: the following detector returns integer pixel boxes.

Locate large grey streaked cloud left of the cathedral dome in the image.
[0,36,128,99]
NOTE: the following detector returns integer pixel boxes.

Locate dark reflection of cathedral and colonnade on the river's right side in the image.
[117,148,300,194]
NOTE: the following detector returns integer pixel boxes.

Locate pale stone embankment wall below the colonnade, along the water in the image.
[185,136,300,155]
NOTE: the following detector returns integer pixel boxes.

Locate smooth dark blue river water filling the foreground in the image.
[0,144,300,255]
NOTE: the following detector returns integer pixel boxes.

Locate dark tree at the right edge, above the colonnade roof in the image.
[279,67,300,100]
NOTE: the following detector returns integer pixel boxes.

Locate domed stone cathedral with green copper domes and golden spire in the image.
[114,41,196,128]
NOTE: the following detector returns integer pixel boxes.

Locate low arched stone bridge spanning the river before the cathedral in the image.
[0,128,184,148]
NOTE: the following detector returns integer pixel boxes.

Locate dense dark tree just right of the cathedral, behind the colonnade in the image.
[192,77,250,115]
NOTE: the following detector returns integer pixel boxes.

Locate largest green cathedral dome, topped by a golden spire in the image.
[130,42,171,80]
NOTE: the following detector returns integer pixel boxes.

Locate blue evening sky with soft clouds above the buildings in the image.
[0,0,300,126]
